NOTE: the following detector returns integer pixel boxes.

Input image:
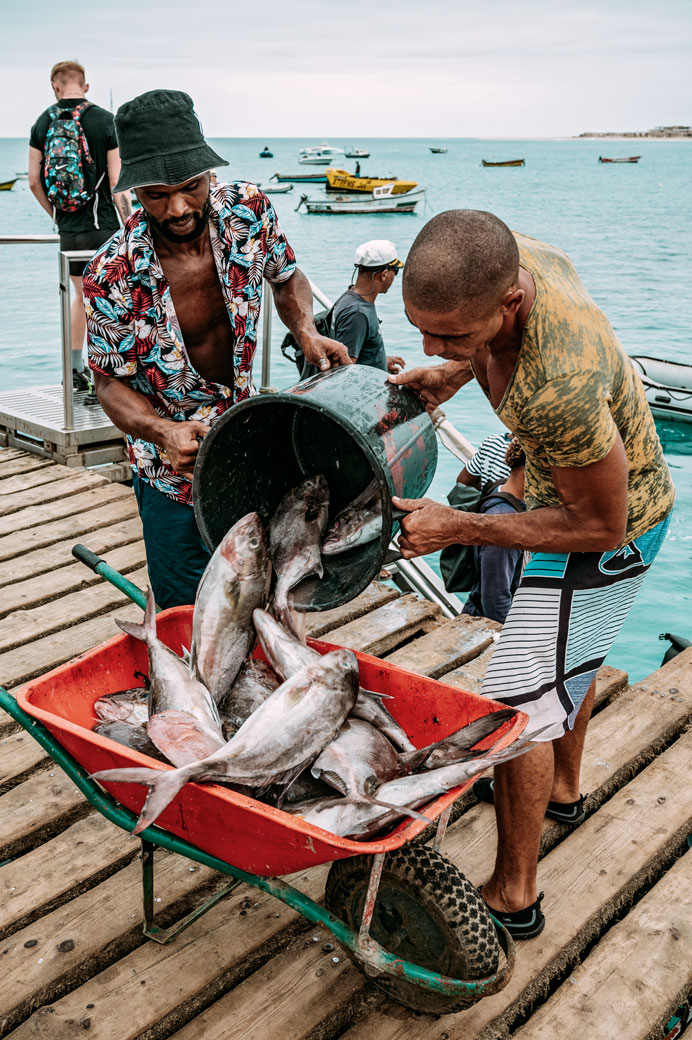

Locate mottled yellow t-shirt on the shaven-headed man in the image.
[497,234,674,545]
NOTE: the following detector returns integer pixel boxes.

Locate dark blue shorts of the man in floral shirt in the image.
[132,475,211,608]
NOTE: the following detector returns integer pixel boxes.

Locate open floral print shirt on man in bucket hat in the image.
[82,181,296,504]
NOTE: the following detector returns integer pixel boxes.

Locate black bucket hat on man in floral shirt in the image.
[112,90,228,192]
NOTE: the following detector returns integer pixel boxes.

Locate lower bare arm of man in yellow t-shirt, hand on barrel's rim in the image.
[393,435,627,558]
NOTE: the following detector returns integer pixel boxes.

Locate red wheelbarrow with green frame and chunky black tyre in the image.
[0,546,528,1014]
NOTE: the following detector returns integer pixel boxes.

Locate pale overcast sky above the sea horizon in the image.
[0,0,692,142]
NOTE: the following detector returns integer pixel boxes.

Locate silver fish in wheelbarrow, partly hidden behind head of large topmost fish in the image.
[252,610,405,751]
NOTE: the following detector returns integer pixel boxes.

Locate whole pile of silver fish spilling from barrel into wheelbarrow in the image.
[94,476,530,838]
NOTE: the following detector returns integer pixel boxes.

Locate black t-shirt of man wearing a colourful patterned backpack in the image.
[29,98,120,232]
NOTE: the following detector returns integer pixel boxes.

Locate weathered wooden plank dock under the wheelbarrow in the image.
[0,449,692,1040]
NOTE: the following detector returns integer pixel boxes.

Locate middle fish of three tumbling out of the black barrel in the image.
[270,474,329,630]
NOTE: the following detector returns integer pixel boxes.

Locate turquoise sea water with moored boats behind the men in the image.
[0,138,692,678]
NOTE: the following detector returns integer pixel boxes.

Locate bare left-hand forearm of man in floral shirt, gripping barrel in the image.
[94,371,209,476]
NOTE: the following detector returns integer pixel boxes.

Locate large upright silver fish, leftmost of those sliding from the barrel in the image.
[190,513,271,704]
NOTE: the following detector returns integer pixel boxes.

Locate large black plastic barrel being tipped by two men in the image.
[193,365,437,610]
